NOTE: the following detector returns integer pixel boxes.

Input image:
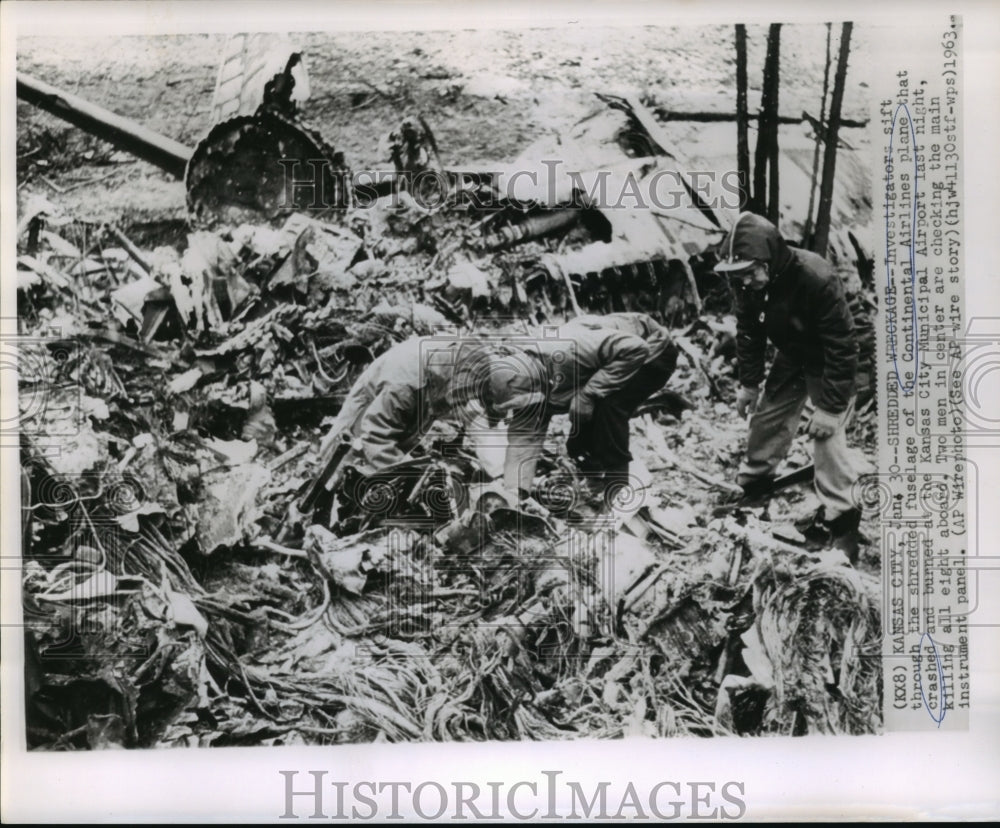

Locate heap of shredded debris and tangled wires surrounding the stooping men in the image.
[18,196,880,750]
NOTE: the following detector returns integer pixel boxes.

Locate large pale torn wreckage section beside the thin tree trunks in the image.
[468,95,722,324]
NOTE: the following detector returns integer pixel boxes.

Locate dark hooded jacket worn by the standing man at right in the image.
[725,213,858,414]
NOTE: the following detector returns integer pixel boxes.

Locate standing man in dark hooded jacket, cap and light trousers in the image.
[715,213,860,561]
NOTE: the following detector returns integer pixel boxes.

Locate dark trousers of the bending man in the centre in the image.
[566,345,677,475]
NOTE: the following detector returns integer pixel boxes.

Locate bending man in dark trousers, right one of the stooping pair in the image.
[487,313,677,502]
